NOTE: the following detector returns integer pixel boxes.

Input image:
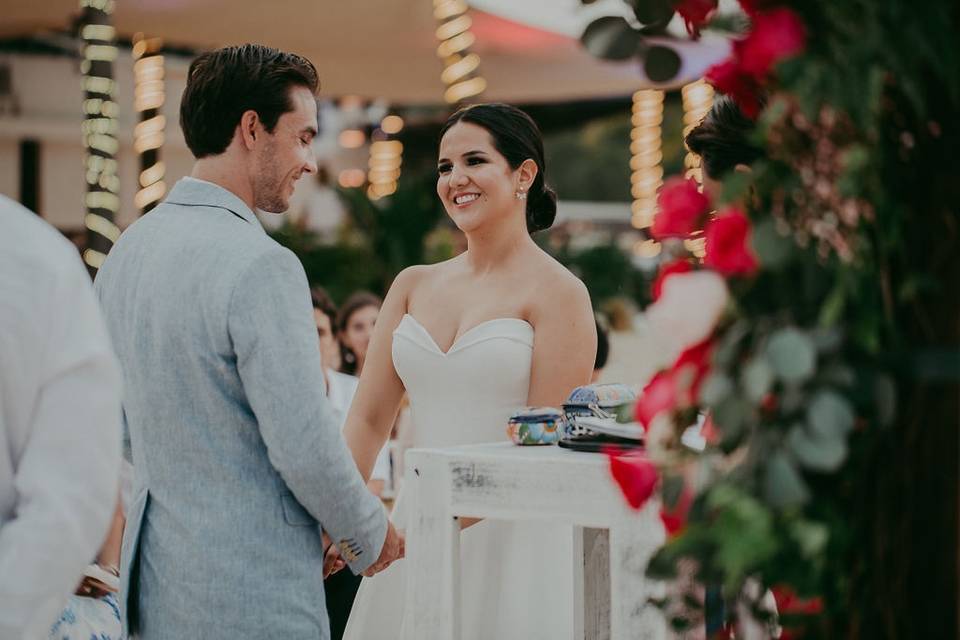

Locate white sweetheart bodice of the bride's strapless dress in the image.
[393,314,533,447]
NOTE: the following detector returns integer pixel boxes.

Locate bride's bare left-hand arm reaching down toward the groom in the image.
[343,267,422,480]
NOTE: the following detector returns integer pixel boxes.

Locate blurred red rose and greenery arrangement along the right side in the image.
[584,0,960,638]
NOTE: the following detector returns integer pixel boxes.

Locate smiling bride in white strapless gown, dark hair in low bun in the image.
[344,104,597,640]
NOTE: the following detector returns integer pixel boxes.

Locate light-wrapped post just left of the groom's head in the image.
[133,33,167,213]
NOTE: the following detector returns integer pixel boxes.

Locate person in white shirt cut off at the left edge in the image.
[0,196,121,639]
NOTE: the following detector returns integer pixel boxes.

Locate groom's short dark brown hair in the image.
[180,44,320,159]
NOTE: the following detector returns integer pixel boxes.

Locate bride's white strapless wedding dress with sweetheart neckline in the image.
[344,315,573,640]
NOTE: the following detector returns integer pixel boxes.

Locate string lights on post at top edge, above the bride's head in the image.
[433,0,487,104]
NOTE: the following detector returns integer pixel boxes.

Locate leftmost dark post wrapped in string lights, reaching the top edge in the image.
[80,0,120,275]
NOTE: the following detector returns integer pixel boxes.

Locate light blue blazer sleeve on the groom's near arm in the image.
[227,245,387,573]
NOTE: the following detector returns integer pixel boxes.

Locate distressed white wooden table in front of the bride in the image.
[403,442,667,640]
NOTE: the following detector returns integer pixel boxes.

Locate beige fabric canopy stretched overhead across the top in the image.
[0,0,725,104]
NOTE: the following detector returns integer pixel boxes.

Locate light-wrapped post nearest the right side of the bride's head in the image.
[630,89,663,229]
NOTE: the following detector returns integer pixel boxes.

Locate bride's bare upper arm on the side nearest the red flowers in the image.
[527,274,597,407]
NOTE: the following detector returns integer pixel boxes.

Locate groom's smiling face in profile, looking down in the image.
[253,86,317,213]
